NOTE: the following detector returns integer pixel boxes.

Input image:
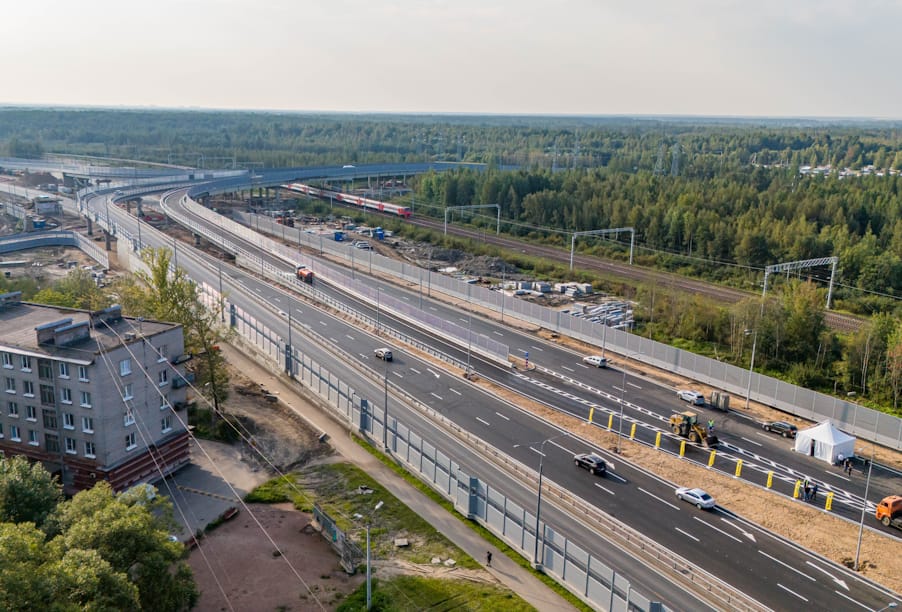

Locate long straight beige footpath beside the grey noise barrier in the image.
[222,345,575,612]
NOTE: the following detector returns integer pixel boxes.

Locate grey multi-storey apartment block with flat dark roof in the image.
[0,292,189,492]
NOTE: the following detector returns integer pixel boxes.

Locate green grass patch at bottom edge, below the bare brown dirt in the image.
[337,576,535,612]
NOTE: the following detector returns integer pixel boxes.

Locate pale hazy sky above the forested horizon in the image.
[0,0,902,119]
